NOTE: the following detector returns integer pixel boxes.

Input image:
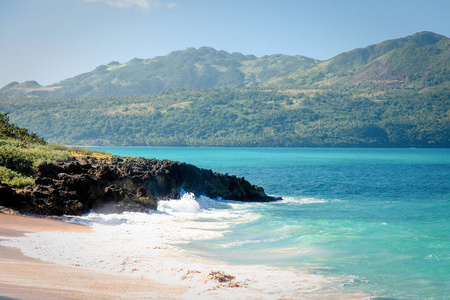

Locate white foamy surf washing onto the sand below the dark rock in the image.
[0,193,366,299]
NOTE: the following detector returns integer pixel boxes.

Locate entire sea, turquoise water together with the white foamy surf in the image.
[0,147,450,299]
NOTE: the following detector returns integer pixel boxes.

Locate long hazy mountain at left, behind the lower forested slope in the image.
[0,47,318,98]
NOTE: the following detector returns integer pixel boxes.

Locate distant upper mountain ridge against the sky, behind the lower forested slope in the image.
[0,31,450,98]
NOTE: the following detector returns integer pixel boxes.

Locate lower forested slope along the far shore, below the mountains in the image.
[0,88,450,147]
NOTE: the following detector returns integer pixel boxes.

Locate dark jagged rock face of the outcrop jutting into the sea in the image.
[0,157,276,215]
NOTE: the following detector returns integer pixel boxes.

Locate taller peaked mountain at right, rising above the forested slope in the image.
[265,31,450,89]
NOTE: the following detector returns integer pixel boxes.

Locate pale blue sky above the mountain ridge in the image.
[0,0,450,88]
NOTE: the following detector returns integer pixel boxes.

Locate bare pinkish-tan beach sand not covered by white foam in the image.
[0,214,187,299]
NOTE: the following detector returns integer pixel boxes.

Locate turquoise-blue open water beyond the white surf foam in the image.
[93,147,450,299]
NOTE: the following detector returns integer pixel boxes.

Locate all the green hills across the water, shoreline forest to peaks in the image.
[0,32,450,147]
